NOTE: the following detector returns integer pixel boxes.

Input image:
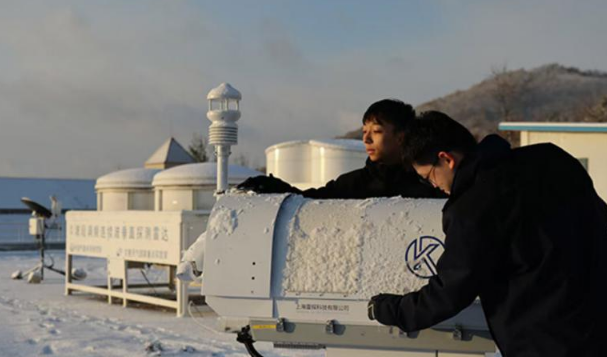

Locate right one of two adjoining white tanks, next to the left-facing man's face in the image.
[310,139,367,186]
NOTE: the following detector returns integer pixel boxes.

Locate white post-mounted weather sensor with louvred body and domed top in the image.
[207,83,242,193]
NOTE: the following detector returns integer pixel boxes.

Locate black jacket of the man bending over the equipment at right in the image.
[376,136,607,357]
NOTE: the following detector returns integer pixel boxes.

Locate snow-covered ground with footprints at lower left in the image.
[0,251,324,357]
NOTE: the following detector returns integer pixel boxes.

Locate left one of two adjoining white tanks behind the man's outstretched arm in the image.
[266,140,312,185]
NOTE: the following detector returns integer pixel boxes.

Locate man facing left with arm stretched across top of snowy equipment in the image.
[238,99,444,199]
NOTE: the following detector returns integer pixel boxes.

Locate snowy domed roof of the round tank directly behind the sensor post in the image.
[152,162,263,187]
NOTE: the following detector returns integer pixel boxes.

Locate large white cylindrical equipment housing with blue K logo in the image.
[203,194,495,356]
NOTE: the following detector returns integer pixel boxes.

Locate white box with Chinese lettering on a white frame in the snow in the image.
[65,211,207,316]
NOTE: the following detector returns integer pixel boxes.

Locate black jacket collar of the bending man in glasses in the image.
[445,134,510,203]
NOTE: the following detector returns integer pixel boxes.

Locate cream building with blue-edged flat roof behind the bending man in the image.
[499,122,607,200]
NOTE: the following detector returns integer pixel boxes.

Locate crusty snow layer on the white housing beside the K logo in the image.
[281,198,444,299]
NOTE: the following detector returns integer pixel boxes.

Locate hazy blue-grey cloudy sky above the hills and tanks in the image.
[0,0,607,178]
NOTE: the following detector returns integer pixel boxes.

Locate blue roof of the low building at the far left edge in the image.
[0,177,97,210]
